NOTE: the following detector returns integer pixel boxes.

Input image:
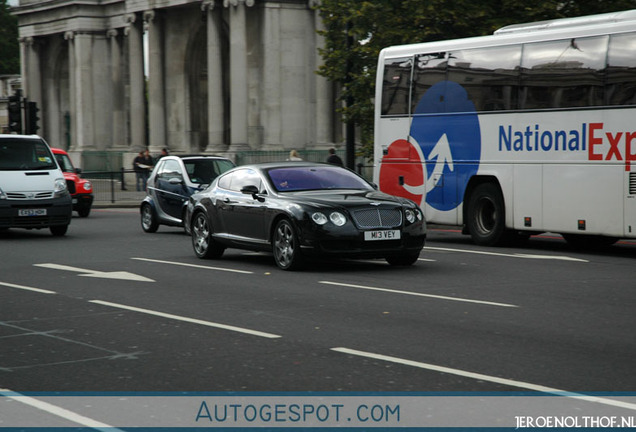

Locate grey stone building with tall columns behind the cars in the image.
[12,0,341,167]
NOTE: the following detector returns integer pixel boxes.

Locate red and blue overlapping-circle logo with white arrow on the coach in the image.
[379,81,481,211]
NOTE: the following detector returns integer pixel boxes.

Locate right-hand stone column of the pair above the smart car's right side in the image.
[223,0,254,152]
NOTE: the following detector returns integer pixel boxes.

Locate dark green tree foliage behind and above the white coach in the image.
[317,0,636,157]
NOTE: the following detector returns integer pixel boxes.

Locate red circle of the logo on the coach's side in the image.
[379,139,426,205]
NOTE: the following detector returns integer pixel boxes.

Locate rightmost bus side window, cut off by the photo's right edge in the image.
[605,33,636,105]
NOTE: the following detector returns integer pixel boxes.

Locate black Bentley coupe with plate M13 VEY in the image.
[186,162,426,270]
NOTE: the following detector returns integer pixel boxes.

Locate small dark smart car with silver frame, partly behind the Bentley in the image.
[140,155,234,233]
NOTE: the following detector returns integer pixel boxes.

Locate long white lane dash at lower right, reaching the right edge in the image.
[331,347,636,410]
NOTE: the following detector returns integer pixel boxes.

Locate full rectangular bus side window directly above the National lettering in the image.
[520,36,608,109]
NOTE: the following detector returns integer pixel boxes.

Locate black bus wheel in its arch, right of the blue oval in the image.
[466,183,506,246]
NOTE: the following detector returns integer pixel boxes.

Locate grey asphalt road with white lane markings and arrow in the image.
[0,209,636,392]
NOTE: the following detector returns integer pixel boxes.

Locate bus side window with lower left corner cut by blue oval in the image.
[448,45,521,111]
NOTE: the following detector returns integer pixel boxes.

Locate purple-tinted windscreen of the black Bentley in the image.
[267,166,373,192]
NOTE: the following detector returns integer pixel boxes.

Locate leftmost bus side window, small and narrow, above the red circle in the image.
[381,58,413,115]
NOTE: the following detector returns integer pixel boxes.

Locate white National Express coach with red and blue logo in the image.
[374,10,636,245]
